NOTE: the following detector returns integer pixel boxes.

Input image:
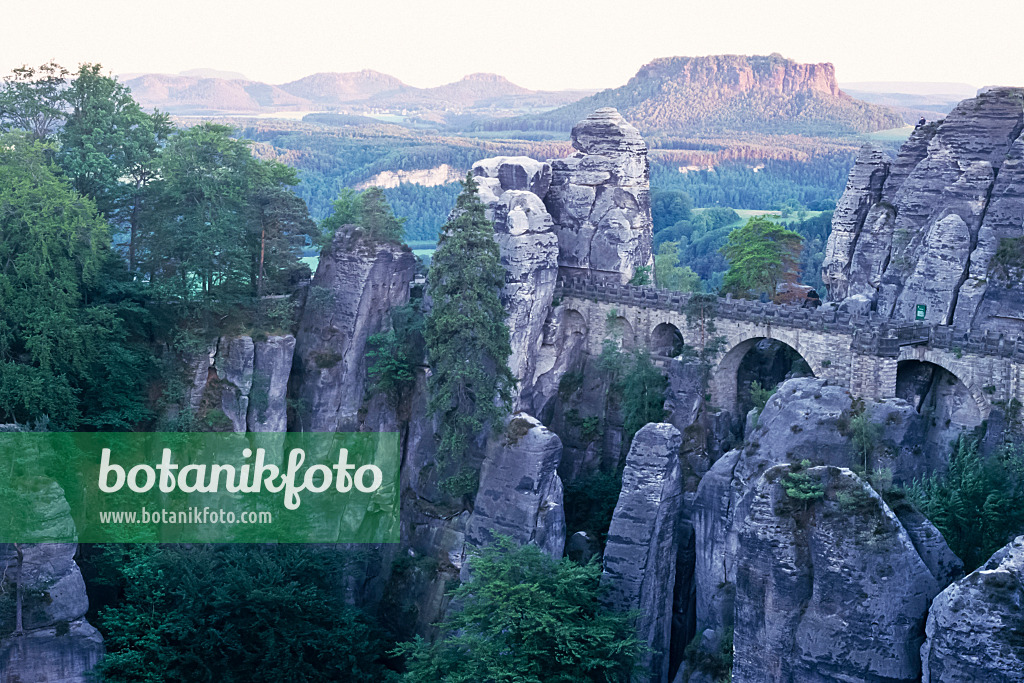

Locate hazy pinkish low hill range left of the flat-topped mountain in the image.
[126,70,593,120]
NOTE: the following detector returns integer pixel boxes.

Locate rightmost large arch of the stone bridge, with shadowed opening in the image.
[896,347,992,427]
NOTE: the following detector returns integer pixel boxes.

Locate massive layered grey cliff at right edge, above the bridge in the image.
[822,88,1024,334]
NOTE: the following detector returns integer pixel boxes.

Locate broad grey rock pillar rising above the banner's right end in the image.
[292,232,416,431]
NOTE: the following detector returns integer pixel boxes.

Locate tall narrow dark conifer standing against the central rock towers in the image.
[426,175,515,494]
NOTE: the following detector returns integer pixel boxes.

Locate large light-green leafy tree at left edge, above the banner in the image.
[0,134,145,429]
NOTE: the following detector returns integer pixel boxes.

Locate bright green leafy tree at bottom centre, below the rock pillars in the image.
[398,538,643,683]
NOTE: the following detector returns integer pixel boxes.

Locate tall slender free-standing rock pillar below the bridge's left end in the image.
[601,423,682,681]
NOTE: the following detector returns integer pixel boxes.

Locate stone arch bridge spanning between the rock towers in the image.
[555,279,1024,421]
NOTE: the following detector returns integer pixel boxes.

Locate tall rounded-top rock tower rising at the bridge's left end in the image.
[544,108,653,283]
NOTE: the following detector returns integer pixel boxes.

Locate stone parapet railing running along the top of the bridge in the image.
[556,278,1024,362]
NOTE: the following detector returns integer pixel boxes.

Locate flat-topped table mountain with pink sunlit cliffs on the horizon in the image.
[495,54,903,135]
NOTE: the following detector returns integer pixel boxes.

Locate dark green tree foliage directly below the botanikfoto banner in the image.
[98,545,385,683]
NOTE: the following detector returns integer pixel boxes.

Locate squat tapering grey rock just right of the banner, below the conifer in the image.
[466,413,565,558]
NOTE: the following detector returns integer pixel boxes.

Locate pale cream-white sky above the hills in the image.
[0,0,1024,89]
